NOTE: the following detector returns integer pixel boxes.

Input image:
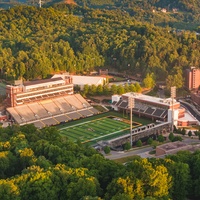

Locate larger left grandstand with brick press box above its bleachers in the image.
[6,75,98,128]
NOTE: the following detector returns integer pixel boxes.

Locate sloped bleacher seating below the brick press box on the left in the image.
[7,94,98,128]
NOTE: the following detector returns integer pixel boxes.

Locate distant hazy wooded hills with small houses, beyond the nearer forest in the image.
[0,0,200,30]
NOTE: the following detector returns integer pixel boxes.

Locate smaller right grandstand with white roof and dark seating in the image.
[112,93,198,126]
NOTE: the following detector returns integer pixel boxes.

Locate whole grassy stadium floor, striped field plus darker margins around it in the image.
[57,112,151,145]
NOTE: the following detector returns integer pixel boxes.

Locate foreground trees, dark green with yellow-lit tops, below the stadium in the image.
[0,125,200,200]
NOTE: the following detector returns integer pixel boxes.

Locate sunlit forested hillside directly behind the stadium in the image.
[0,4,200,88]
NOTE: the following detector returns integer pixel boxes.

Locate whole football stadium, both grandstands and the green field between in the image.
[6,74,196,144]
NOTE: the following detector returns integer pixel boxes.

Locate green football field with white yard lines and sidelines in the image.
[60,116,142,143]
